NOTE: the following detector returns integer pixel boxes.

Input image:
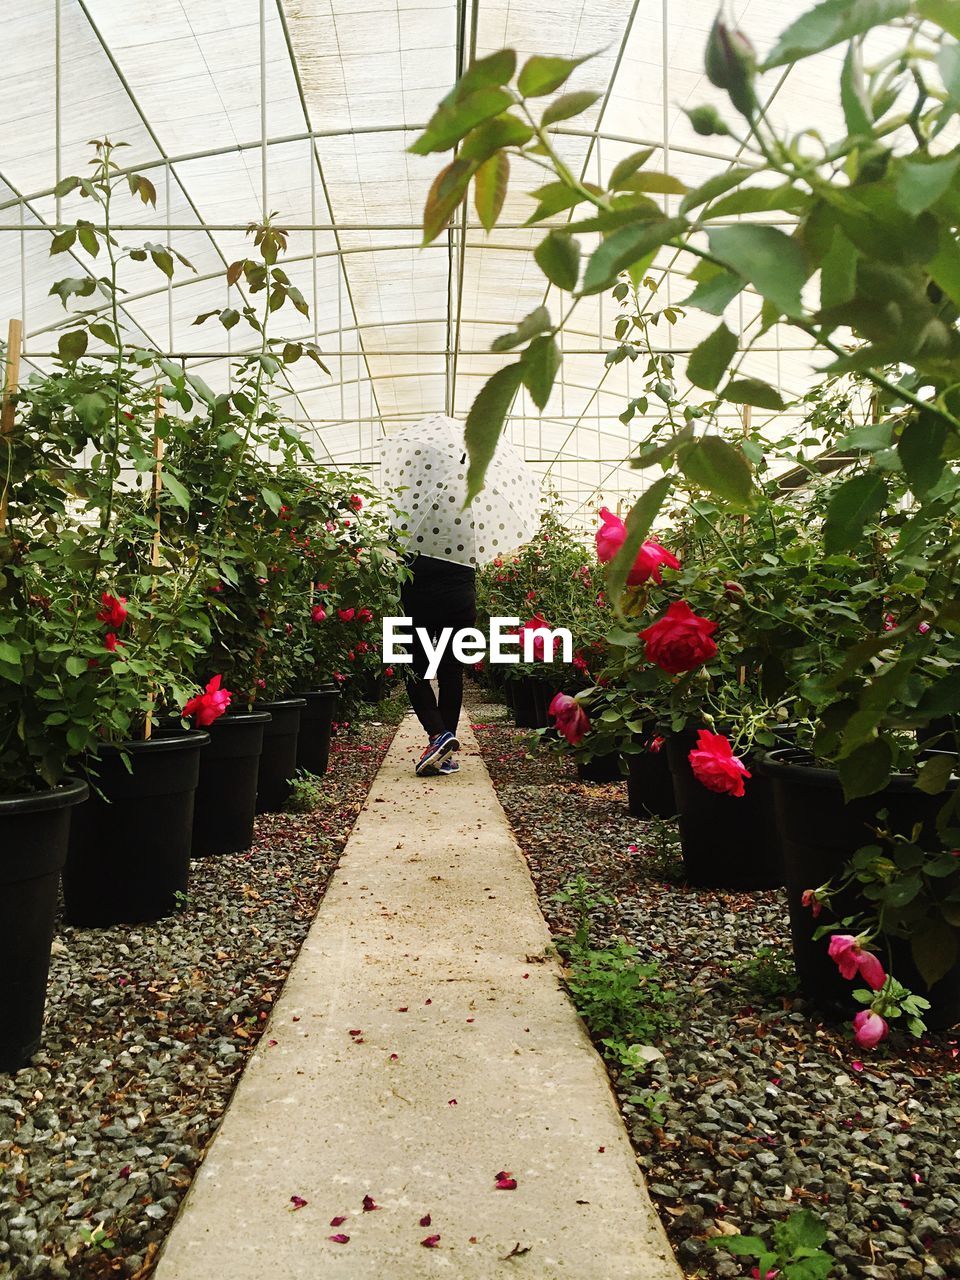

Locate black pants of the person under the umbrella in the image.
[403,580,476,737]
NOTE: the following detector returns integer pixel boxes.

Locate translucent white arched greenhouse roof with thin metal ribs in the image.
[0,0,901,520]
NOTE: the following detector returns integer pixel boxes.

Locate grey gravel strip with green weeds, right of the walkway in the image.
[470,692,960,1280]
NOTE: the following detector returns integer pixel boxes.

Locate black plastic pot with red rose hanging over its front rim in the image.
[666,731,783,890]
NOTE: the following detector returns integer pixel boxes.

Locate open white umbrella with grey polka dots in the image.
[381,413,540,566]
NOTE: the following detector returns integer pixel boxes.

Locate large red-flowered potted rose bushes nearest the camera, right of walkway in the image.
[411,0,960,1043]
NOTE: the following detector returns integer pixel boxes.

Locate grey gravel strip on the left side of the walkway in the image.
[0,723,394,1280]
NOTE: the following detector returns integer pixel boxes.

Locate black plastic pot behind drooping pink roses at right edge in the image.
[760,748,960,1029]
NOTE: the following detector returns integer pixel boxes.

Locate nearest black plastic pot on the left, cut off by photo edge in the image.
[0,778,87,1071]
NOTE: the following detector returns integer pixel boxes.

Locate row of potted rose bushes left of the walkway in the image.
[0,141,406,1070]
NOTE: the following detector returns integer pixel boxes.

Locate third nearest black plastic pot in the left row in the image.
[193,712,270,858]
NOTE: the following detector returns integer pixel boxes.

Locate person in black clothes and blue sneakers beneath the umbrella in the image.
[401,554,476,777]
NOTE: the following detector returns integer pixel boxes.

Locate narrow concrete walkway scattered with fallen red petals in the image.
[155,718,682,1280]
